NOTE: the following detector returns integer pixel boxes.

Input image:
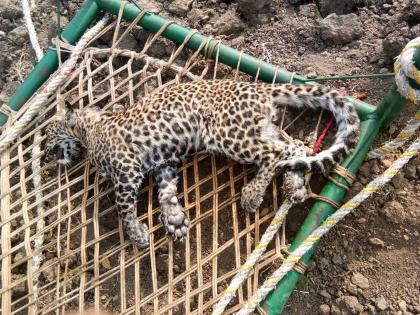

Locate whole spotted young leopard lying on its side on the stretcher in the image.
[46,80,359,247]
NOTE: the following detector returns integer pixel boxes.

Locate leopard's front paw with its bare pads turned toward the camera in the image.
[159,196,190,241]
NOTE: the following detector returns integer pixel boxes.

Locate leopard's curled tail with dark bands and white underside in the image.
[273,84,360,172]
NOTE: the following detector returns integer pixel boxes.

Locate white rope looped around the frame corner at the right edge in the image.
[394,37,420,103]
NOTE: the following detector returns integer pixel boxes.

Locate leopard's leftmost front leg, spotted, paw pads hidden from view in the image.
[113,174,149,248]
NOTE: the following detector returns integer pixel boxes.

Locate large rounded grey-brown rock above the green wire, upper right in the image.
[319,13,362,44]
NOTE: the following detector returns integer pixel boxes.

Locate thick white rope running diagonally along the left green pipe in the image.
[0,17,108,154]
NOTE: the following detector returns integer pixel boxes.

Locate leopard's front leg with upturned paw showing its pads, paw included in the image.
[154,164,190,240]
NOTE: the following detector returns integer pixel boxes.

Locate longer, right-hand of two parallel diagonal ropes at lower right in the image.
[236,137,420,315]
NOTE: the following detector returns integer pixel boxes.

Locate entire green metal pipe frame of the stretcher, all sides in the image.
[0,0,420,314]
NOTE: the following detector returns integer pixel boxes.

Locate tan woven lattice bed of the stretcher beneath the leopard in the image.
[0,8,334,314]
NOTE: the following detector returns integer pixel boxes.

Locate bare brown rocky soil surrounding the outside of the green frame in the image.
[0,0,420,315]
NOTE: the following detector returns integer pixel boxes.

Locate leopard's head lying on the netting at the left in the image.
[45,115,84,165]
